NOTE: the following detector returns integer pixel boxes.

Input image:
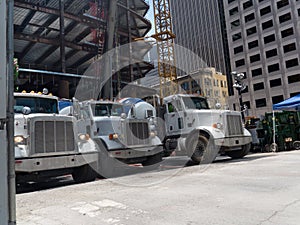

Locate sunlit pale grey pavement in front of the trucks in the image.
[17,151,300,225]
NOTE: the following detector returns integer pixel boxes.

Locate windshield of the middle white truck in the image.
[93,104,124,117]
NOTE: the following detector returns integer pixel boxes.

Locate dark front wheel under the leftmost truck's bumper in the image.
[72,165,97,183]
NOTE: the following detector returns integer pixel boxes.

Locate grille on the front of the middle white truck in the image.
[126,121,149,146]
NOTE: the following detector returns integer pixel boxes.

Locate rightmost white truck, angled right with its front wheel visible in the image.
[163,94,252,163]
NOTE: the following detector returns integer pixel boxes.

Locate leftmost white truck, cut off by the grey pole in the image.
[14,93,99,183]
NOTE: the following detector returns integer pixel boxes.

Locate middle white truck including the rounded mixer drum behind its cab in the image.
[60,100,163,178]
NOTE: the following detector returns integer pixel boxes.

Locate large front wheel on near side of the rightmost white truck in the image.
[191,136,218,164]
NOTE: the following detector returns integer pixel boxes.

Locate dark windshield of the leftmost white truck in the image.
[14,97,58,113]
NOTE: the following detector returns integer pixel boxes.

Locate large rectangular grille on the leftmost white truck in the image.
[32,121,75,153]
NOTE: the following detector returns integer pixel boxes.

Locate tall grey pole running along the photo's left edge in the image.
[0,0,16,225]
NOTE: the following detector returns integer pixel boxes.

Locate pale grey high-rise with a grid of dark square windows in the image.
[223,0,300,116]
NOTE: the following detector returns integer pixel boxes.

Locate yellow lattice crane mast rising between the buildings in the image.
[152,0,178,99]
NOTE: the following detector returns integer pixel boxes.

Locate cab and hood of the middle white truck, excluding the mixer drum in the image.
[81,101,163,166]
